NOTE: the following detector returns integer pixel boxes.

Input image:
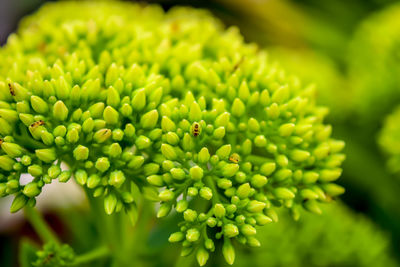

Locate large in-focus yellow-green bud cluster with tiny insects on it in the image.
[0,2,344,265]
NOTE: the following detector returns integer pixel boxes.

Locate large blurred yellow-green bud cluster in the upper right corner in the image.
[349,4,400,123]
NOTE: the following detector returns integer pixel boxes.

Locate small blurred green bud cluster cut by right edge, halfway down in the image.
[378,107,400,176]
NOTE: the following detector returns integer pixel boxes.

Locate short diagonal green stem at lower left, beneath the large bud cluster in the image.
[24,206,60,245]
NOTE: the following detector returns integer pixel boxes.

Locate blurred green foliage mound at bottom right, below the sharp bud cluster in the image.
[233,203,397,267]
